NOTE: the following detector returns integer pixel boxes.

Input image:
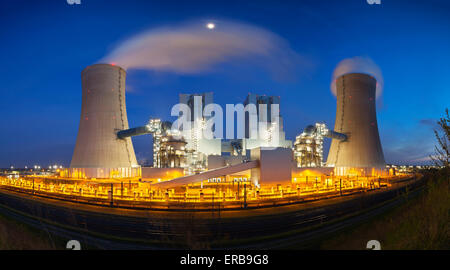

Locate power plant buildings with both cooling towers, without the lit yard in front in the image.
[60,64,388,188]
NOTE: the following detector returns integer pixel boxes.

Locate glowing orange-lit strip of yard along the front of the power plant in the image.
[0,169,409,208]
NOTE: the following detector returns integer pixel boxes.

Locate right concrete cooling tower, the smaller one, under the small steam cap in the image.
[327,73,386,176]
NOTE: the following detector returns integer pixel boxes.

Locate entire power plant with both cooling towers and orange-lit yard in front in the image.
[0,60,412,230]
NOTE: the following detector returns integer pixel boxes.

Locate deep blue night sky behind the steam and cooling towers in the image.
[0,0,450,167]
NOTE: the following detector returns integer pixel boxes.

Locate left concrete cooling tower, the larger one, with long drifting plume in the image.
[68,64,140,178]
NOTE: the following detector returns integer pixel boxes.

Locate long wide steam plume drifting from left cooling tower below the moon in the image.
[100,21,303,79]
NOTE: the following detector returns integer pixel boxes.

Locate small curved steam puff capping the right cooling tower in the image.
[331,56,384,98]
